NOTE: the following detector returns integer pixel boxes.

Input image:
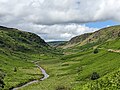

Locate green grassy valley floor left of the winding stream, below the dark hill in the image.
[0,51,42,89]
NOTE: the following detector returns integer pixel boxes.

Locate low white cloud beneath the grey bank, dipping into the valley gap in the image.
[17,24,98,41]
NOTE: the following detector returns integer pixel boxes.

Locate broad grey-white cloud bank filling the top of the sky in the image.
[0,0,120,24]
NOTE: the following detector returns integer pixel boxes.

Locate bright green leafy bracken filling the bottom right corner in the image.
[82,70,120,90]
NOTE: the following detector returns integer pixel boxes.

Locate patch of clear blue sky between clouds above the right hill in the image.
[85,20,120,28]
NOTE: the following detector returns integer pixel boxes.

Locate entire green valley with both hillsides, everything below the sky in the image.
[0,26,120,90]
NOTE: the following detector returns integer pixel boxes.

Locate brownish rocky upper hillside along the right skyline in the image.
[59,25,120,48]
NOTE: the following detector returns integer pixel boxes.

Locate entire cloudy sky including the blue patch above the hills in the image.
[0,0,120,41]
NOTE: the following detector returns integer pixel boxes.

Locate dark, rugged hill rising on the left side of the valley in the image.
[0,26,50,52]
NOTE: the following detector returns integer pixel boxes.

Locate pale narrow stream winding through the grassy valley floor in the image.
[12,64,49,90]
